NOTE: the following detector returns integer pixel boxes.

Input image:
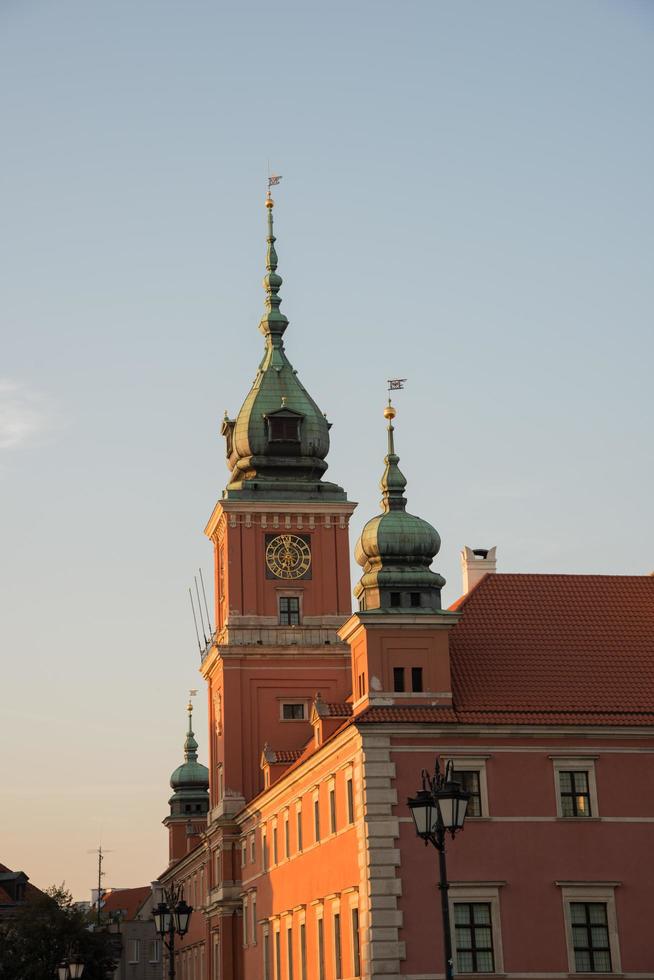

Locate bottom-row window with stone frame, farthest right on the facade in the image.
[557,881,622,973]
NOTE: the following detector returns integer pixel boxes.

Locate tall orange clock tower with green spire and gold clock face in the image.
[202,192,356,823]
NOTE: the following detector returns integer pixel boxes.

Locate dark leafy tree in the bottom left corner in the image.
[0,884,116,980]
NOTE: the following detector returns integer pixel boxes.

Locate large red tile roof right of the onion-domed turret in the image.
[450,574,654,725]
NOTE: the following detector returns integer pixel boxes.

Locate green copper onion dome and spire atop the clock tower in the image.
[222,191,345,500]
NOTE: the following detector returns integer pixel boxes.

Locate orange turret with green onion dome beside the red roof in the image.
[338,400,458,714]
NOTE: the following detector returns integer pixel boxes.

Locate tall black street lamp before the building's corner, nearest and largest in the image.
[407,759,470,980]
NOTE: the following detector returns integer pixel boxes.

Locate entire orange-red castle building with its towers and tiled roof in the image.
[160,199,654,980]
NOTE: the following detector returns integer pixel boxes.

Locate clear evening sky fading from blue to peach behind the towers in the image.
[0,0,654,899]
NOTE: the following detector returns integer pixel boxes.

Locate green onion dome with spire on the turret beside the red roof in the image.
[354,399,445,613]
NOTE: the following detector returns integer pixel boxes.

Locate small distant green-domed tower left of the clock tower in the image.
[163,699,209,862]
